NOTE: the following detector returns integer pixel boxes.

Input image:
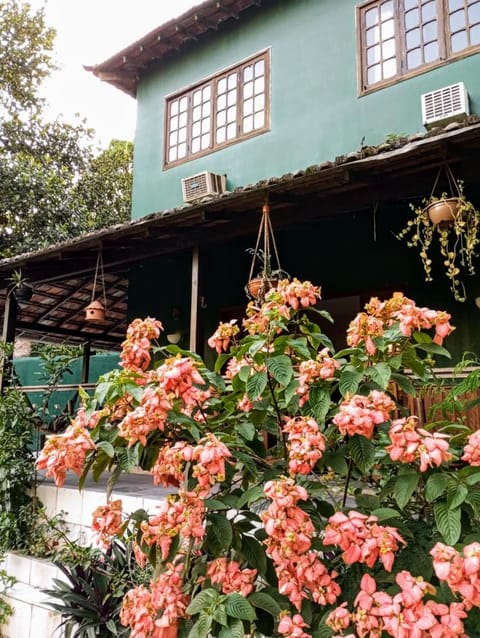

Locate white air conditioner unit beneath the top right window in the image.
[422,82,470,128]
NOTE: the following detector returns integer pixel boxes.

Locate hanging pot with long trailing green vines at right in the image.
[396,164,480,301]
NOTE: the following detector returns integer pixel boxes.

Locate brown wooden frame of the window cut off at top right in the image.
[356,0,480,97]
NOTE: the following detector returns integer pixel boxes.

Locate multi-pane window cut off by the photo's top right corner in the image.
[358,0,480,91]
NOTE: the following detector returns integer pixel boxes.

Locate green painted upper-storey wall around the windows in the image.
[132,0,480,219]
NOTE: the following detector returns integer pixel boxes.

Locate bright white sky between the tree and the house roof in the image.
[29,0,200,148]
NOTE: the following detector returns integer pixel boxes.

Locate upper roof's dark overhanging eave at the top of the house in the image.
[85,0,262,97]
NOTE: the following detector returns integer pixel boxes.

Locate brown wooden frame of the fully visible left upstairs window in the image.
[163,48,271,170]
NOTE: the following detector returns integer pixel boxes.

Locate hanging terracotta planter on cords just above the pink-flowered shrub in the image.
[245,201,290,303]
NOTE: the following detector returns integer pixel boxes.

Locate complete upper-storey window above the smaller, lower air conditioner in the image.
[164,52,270,167]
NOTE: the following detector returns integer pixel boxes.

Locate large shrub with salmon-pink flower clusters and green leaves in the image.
[38,280,480,638]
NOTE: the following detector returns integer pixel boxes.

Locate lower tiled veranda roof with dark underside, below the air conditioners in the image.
[0,116,480,348]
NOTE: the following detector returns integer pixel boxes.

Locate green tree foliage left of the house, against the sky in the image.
[0,0,132,256]
